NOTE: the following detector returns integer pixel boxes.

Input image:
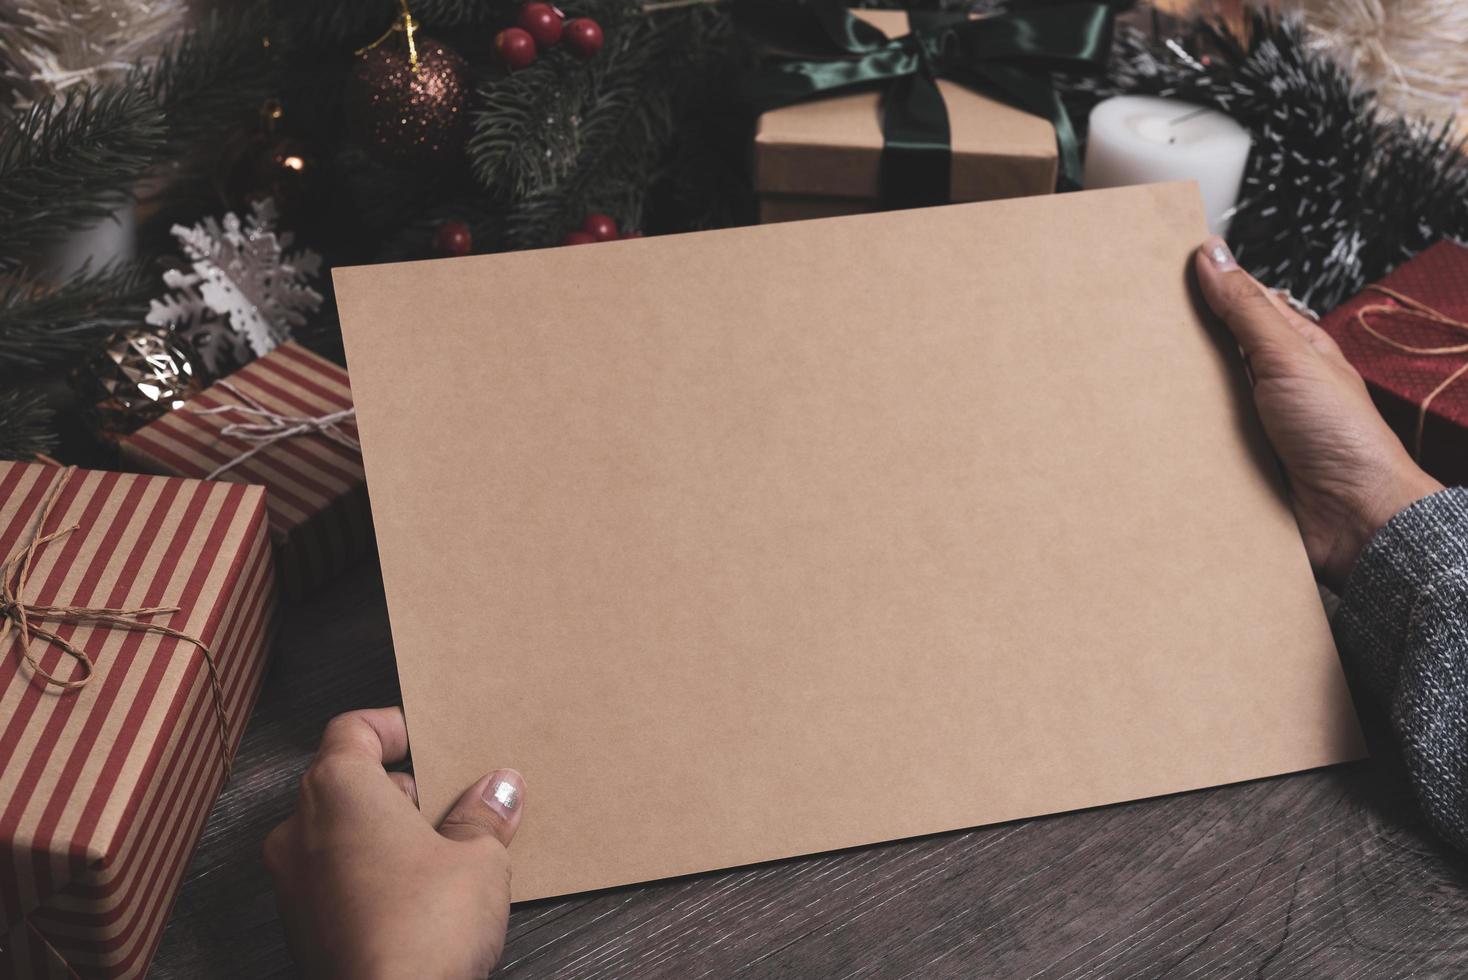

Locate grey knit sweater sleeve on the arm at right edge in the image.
[1334,487,1468,849]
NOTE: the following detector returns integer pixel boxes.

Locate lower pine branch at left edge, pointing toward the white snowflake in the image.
[0,263,156,371]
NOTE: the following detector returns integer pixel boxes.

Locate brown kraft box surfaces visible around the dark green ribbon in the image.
[755,10,1057,224]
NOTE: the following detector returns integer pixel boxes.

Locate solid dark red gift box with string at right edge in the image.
[1320,242,1468,484]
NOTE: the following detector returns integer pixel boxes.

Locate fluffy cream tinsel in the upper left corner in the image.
[0,0,188,109]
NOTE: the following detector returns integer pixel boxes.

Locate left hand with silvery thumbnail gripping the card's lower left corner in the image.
[264,707,524,979]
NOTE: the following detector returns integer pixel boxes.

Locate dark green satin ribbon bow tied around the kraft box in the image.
[745,0,1113,208]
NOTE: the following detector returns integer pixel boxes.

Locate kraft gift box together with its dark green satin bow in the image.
[745,0,1113,222]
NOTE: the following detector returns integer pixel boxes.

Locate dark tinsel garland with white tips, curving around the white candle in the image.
[1067,13,1468,310]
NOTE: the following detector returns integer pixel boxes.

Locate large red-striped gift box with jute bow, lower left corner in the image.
[0,462,275,977]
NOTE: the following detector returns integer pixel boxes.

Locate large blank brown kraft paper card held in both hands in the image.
[336,183,1362,899]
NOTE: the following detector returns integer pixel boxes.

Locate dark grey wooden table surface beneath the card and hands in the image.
[151,565,1468,980]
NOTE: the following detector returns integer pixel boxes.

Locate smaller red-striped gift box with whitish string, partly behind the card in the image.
[119,342,371,597]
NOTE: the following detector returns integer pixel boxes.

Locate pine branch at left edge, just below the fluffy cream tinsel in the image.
[0,87,166,267]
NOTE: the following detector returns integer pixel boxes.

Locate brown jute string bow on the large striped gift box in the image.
[0,467,229,779]
